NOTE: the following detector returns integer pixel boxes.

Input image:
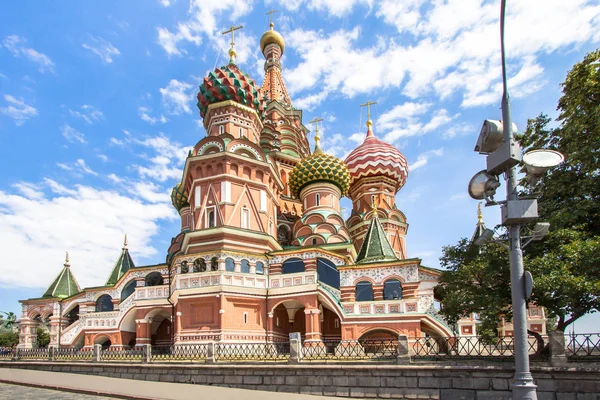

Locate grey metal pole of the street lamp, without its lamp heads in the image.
[500,0,537,400]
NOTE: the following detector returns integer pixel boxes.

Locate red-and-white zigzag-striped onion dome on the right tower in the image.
[345,119,408,192]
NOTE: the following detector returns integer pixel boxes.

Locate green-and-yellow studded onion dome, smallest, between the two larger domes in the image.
[289,133,351,197]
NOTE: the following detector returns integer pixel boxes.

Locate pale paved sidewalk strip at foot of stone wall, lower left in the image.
[0,368,340,400]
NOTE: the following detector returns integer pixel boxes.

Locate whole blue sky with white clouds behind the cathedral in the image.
[0,0,600,331]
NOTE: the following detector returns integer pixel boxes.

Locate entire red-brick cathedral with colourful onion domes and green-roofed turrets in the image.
[19,23,545,348]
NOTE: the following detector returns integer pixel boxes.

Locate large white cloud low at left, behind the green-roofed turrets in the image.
[0,179,177,288]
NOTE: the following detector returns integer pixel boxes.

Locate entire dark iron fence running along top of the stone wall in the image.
[0,333,600,363]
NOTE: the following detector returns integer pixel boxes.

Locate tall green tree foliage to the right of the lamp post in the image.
[518,49,600,332]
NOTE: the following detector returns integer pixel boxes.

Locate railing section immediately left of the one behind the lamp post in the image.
[302,339,398,361]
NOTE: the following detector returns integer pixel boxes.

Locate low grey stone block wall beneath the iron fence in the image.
[0,361,600,400]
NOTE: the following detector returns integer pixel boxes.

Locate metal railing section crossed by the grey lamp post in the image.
[409,336,537,359]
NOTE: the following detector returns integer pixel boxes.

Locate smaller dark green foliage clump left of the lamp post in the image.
[436,238,510,340]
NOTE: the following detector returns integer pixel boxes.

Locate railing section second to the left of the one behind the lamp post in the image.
[215,342,290,361]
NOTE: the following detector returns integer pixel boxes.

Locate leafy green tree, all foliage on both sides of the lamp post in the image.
[437,50,600,335]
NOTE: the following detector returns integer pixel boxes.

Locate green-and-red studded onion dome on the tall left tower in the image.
[197,62,263,118]
